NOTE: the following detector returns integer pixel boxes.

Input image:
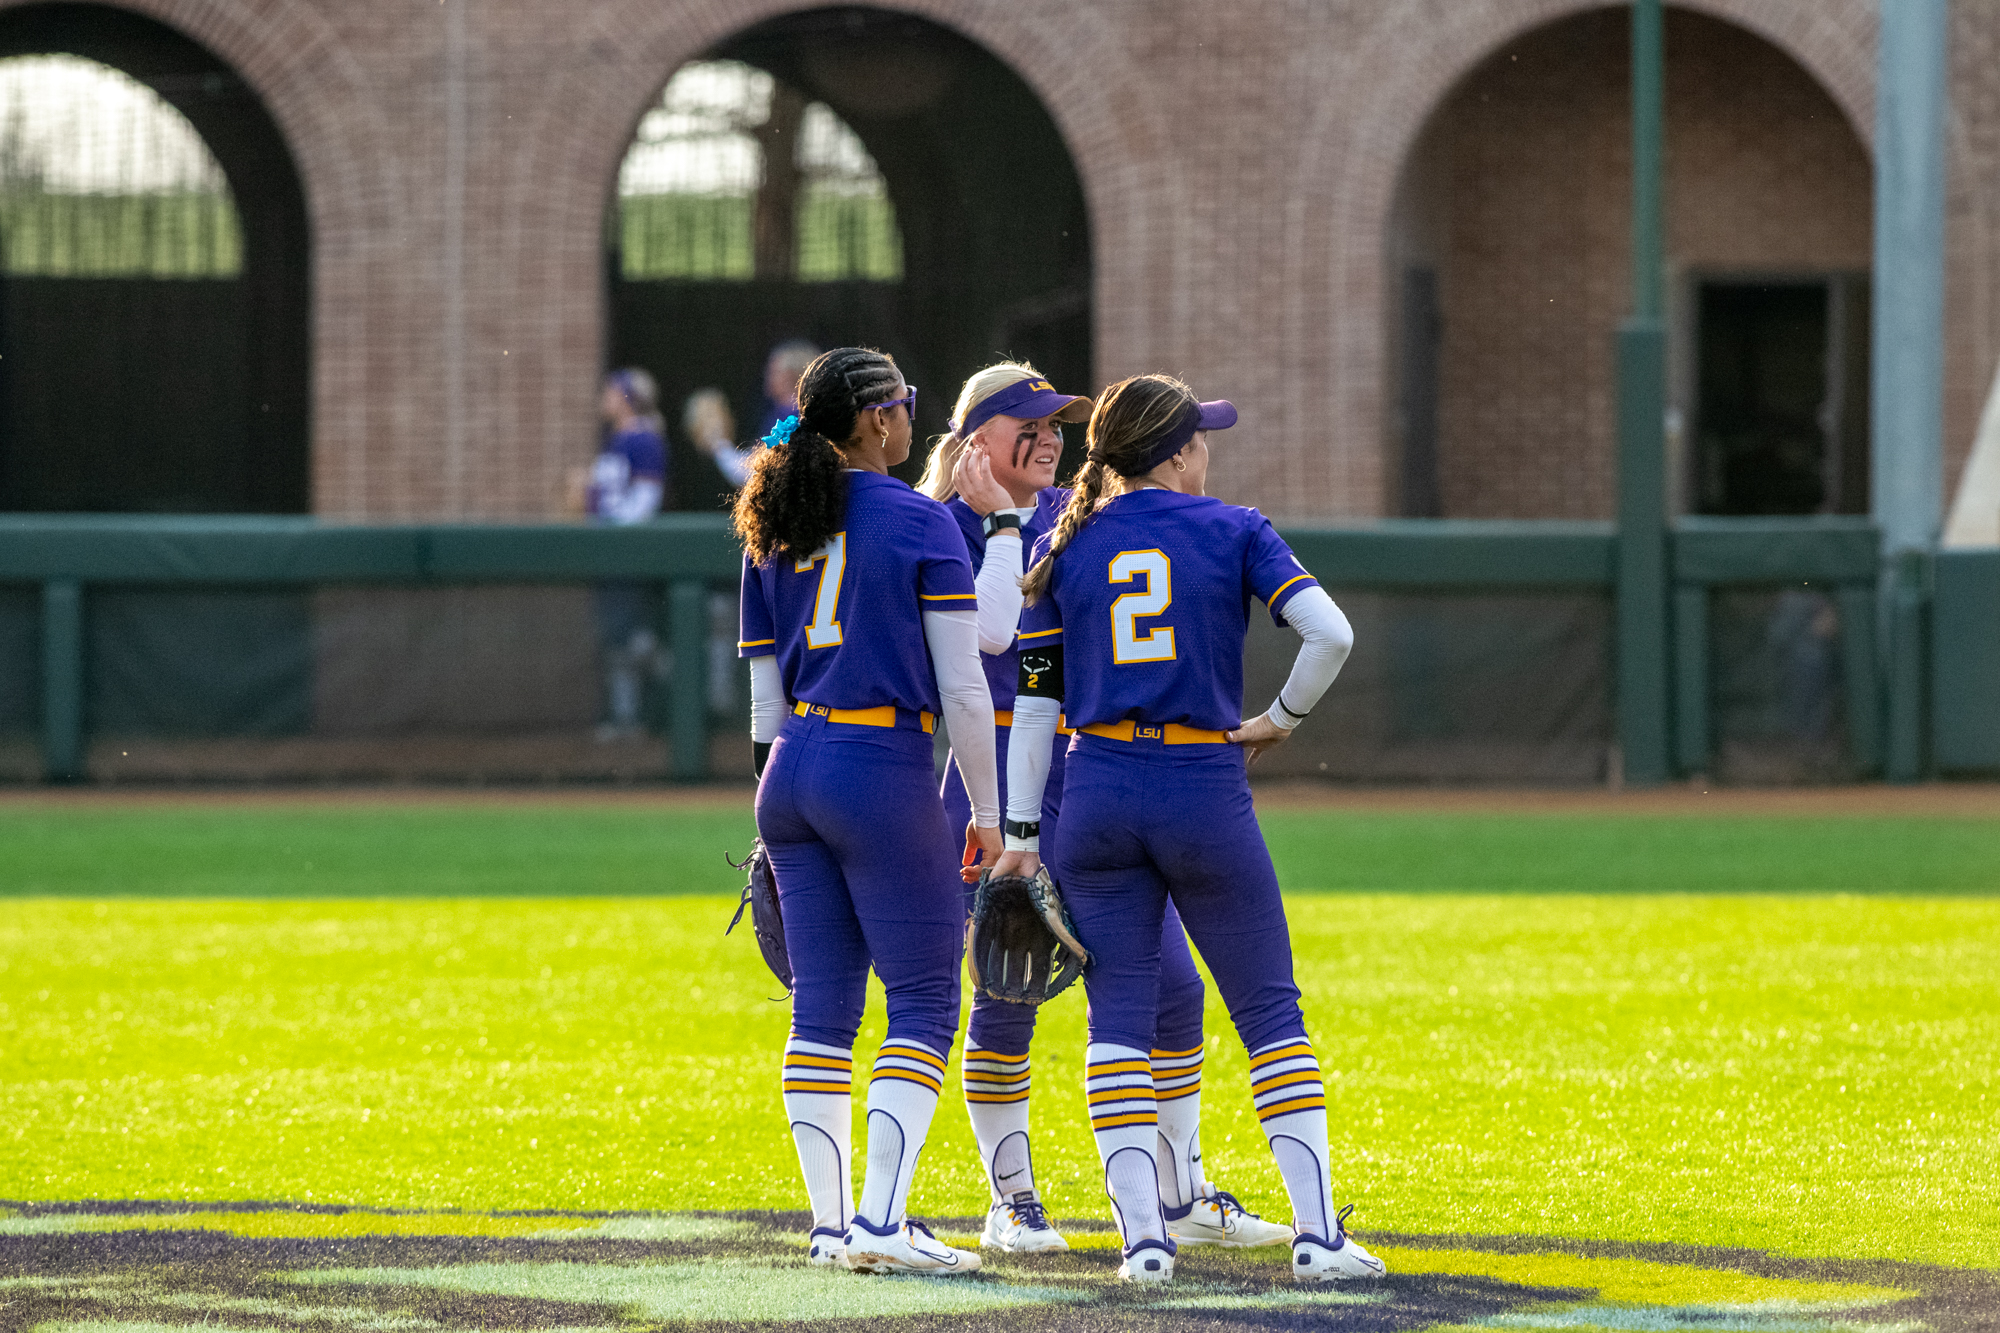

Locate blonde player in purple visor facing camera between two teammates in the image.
[918,362,1292,1253]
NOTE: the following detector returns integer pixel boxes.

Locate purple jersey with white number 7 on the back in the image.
[738,472,978,713]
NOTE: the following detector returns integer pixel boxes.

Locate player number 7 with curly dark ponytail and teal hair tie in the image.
[736,348,1000,1273]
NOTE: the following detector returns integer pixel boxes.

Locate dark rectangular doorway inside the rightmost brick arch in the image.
[1692,274,1868,514]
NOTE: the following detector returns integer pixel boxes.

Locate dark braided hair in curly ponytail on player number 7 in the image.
[734,346,902,564]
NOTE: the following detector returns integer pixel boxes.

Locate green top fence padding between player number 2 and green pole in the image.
[1282,518,1616,588]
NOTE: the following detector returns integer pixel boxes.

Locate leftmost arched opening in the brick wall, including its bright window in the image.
[0,4,310,512]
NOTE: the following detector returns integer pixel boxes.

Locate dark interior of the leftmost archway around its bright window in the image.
[0,4,310,512]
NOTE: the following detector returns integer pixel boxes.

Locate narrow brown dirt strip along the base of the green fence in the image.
[0,781,2000,819]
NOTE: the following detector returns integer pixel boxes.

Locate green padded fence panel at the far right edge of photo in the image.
[1930,550,2000,773]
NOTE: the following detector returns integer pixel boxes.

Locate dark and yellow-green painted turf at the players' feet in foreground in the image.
[0,1203,2000,1333]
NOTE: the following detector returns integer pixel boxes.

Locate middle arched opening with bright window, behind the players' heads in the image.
[606,8,1092,508]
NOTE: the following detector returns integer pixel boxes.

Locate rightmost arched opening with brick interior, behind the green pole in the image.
[1384,8,1872,518]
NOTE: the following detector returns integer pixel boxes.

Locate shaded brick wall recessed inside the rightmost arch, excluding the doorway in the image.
[1398,10,1872,518]
